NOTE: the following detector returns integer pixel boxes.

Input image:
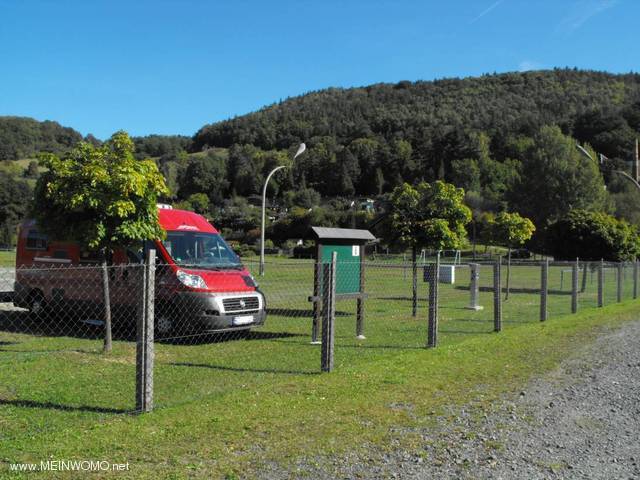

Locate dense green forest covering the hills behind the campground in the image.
[0,69,640,253]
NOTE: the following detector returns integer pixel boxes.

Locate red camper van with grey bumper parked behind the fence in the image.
[14,206,266,334]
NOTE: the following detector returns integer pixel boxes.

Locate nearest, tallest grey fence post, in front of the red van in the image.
[136,249,156,413]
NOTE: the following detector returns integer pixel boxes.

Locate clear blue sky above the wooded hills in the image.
[0,0,640,138]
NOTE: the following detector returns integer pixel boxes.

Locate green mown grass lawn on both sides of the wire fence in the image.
[0,261,640,478]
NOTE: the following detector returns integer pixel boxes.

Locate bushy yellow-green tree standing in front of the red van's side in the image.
[32,131,169,352]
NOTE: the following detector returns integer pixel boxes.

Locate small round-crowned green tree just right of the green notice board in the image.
[390,180,471,316]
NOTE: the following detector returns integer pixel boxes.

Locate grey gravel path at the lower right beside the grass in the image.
[264,321,640,480]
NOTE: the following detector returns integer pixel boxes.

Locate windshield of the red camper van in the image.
[162,232,241,269]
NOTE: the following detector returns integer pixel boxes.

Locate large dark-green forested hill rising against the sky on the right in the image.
[192,69,640,156]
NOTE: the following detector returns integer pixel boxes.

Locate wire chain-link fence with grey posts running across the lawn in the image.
[0,256,638,413]
